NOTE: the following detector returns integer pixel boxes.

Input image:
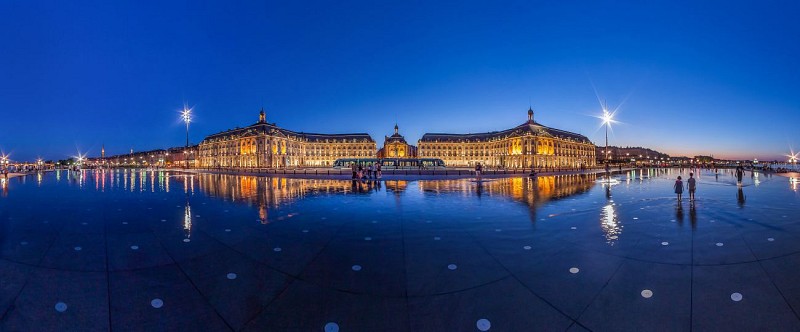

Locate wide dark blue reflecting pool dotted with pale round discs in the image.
[0,169,800,331]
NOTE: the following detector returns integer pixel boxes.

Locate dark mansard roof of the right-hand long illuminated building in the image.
[420,120,592,144]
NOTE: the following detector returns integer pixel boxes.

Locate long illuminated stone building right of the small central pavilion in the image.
[417,109,596,168]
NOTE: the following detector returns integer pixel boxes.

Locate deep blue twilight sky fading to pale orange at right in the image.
[0,0,800,160]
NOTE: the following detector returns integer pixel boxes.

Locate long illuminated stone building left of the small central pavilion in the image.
[199,109,376,168]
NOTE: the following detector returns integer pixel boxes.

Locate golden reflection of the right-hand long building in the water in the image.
[416,174,597,208]
